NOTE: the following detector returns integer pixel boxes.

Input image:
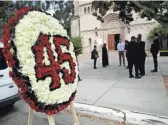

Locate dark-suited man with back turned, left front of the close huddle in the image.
[127,36,141,79]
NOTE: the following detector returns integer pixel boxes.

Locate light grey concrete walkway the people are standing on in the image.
[75,52,168,116]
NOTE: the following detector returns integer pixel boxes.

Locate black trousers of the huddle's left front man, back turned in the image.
[128,60,139,76]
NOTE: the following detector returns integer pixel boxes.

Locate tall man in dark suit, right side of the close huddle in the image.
[137,34,147,76]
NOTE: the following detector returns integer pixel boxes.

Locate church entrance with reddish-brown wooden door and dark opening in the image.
[108,34,120,51]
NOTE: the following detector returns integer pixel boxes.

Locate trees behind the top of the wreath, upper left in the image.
[0,0,73,36]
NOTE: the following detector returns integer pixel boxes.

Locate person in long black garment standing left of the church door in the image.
[102,43,109,68]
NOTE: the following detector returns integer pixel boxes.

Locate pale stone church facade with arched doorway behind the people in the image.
[71,0,158,53]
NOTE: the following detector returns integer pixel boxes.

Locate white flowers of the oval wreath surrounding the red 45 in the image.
[14,11,78,104]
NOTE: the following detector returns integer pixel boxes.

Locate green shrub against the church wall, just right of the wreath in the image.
[70,37,82,55]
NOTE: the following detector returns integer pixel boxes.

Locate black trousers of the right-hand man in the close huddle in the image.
[138,57,146,75]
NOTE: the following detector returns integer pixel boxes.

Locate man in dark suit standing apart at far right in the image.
[150,33,159,72]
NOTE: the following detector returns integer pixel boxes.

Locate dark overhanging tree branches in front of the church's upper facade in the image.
[92,1,168,27]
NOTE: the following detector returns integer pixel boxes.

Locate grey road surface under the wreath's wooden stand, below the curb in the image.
[0,100,117,125]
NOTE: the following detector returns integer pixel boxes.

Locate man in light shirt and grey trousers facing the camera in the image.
[117,39,125,66]
